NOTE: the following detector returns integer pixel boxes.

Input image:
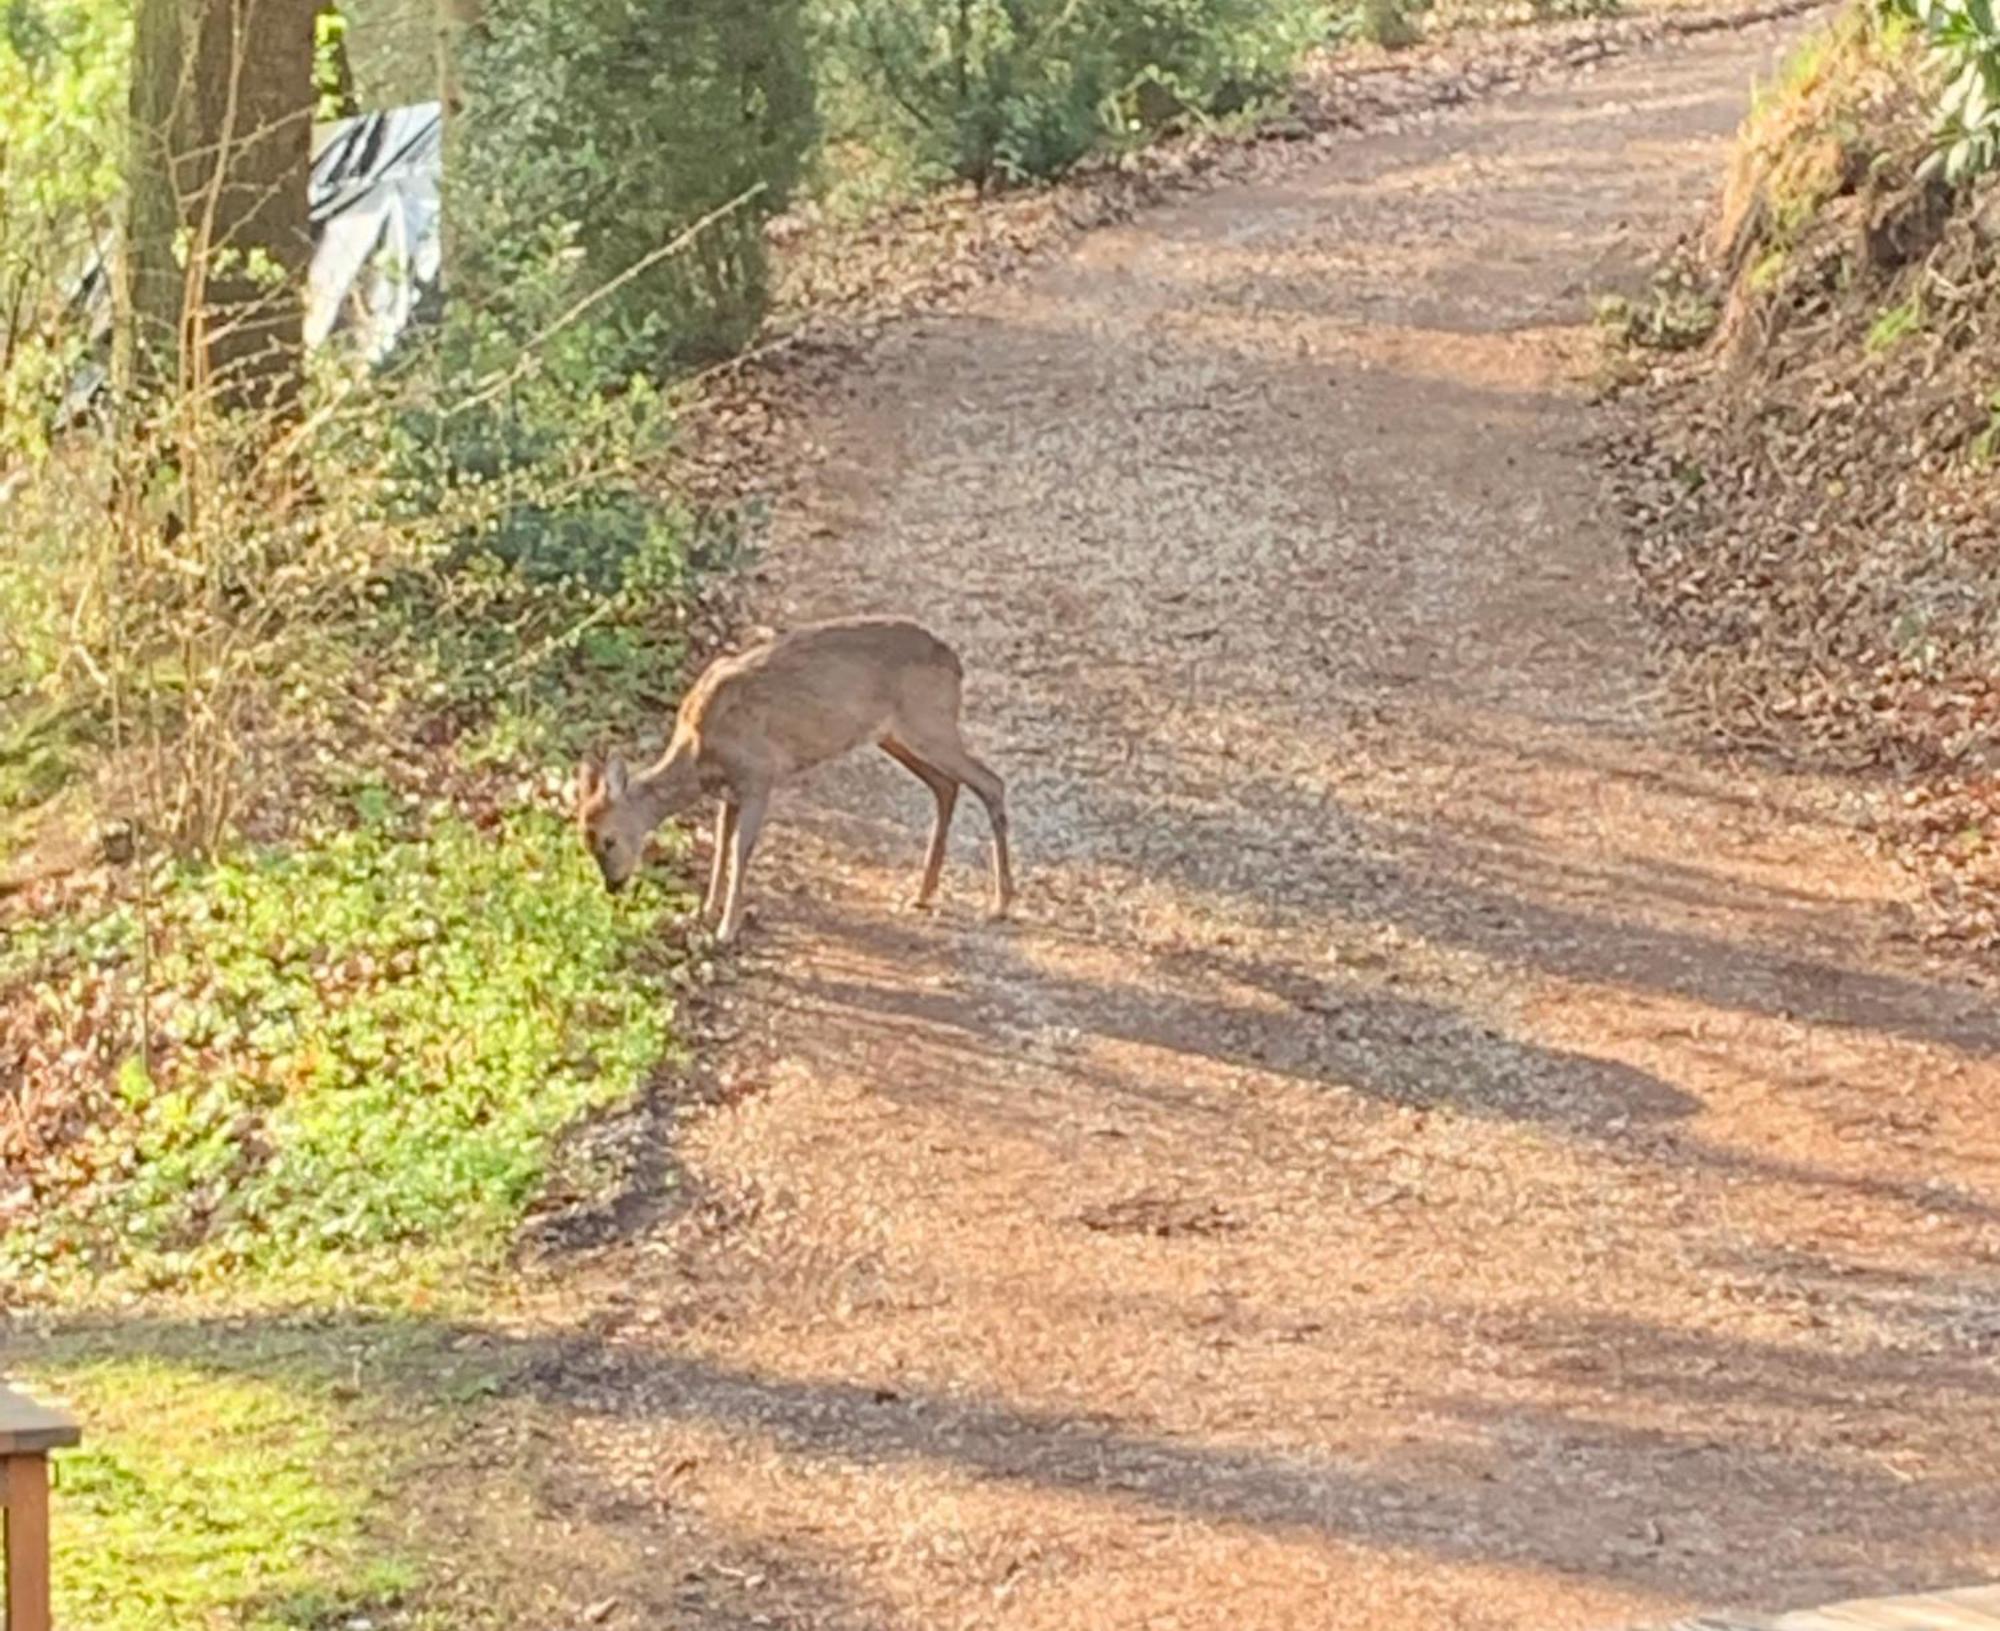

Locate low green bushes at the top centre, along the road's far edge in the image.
[820,0,1328,186]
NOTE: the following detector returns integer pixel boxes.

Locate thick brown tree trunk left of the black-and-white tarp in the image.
[124,0,320,408]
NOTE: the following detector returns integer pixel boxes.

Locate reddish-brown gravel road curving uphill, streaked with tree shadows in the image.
[508,30,2000,1631]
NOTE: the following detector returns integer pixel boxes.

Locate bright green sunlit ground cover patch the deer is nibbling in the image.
[0,807,674,1287]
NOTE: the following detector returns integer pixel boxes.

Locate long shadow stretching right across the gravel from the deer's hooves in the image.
[764,899,2000,1223]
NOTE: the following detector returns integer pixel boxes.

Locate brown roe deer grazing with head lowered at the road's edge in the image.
[576,618,1014,945]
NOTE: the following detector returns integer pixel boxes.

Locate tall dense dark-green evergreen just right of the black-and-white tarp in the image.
[458,0,816,371]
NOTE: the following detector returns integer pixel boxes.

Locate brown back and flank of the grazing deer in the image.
[680,618,960,778]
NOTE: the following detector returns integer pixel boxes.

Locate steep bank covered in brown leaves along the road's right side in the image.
[1630,0,2000,951]
